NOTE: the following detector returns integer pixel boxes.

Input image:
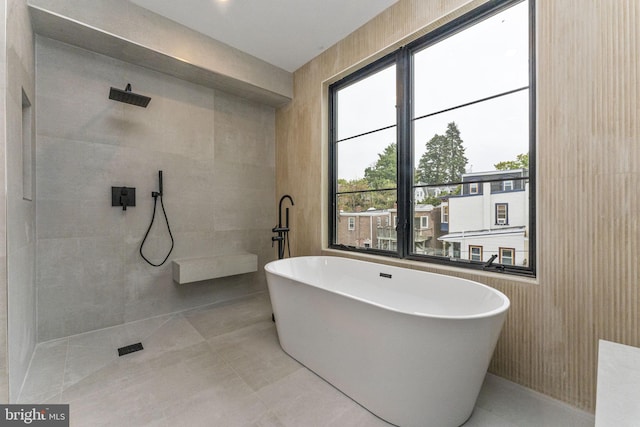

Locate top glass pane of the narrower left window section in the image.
[336,65,396,141]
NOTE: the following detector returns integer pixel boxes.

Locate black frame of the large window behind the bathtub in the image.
[327,0,537,277]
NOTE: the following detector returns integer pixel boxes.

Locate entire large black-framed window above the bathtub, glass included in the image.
[328,0,536,276]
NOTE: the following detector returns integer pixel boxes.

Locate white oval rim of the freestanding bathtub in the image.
[264,255,511,320]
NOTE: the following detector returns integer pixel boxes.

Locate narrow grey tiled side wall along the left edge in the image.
[0,0,37,401]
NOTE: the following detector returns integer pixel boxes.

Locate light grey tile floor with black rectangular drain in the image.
[20,294,594,427]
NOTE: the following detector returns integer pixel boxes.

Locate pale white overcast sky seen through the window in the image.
[338,2,529,180]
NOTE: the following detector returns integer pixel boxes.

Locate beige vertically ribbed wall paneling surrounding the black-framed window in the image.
[276,0,640,411]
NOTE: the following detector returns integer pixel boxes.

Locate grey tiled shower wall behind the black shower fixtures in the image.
[9,32,276,400]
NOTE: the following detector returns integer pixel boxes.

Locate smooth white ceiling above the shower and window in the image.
[129,0,397,71]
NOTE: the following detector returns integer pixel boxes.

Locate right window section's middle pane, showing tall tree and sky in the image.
[413,90,529,184]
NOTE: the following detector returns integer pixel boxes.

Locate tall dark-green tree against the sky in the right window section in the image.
[416,122,468,184]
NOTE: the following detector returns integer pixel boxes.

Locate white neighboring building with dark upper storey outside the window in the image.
[439,169,529,266]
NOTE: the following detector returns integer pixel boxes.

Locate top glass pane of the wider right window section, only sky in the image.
[413,2,529,117]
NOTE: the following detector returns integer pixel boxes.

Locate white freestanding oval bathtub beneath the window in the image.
[265,257,509,427]
